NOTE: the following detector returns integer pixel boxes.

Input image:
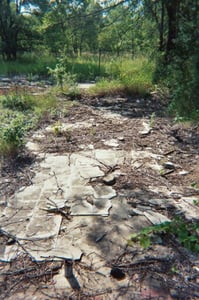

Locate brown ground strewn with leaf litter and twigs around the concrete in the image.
[0,87,199,300]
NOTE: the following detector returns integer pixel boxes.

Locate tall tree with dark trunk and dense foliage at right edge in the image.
[143,0,199,115]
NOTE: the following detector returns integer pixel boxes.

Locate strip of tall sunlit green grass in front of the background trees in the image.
[0,53,155,96]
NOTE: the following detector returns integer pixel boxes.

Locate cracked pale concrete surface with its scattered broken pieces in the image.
[0,103,199,298]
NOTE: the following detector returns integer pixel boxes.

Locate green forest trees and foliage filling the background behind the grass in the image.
[0,0,199,117]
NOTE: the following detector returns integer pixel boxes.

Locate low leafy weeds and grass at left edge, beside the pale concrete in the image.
[0,89,57,155]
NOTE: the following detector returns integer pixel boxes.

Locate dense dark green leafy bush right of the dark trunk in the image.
[156,0,199,121]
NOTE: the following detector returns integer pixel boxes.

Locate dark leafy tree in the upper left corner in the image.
[0,0,49,60]
